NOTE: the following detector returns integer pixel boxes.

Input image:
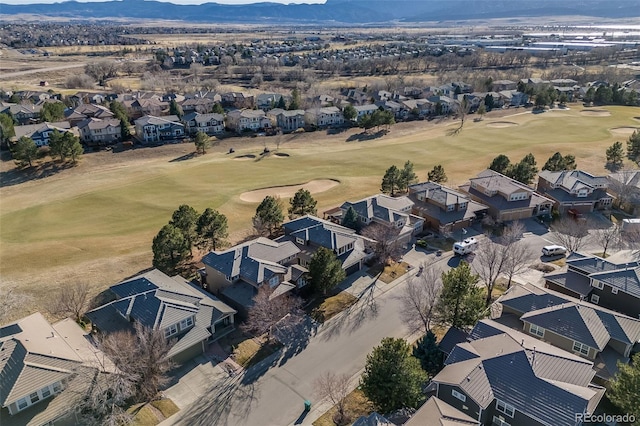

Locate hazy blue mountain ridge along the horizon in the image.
[0,0,640,24]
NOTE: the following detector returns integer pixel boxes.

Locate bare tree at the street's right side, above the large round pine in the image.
[398,264,442,333]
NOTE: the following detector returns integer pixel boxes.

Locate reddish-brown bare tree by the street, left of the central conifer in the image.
[242,285,302,338]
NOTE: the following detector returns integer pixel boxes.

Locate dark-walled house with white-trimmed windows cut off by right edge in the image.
[545,253,640,318]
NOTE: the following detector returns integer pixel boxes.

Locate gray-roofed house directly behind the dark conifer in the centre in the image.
[278,215,373,275]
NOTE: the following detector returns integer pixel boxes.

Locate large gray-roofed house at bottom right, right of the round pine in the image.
[427,320,605,426]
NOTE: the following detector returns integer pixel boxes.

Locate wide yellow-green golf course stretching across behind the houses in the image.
[0,104,638,320]
